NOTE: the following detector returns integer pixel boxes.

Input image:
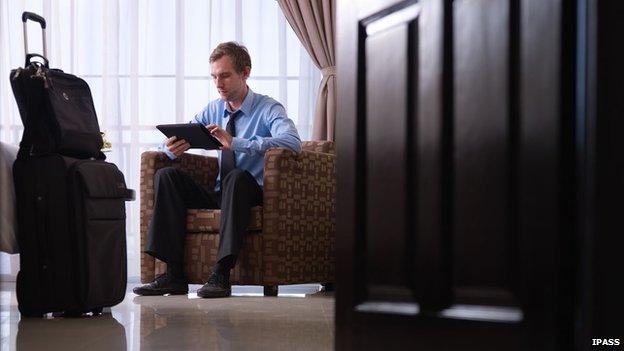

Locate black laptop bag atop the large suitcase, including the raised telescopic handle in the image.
[10,12,104,159]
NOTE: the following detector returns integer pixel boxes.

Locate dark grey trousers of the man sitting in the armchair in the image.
[145,167,262,264]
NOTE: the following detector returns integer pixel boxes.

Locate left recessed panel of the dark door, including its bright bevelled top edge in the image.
[360,0,418,299]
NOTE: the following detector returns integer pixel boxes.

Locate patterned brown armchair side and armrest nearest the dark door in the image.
[262,148,336,284]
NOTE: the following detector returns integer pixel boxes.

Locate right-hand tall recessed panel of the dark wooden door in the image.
[453,0,516,305]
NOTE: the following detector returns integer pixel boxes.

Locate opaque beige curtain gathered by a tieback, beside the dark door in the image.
[277,0,336,140]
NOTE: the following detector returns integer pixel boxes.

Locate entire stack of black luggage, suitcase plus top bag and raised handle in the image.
[11,12,134,316]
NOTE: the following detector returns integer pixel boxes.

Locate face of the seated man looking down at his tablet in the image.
[210,55,249,101]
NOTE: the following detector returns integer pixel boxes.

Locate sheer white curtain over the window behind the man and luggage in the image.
[0,0,320,280]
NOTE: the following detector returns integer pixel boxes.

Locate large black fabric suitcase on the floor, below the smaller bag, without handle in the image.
[13,154,130,316]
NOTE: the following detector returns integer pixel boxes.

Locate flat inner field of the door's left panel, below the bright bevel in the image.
[365,22,408,292]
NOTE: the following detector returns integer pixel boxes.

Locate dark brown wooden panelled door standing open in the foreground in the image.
[336,0,578,350]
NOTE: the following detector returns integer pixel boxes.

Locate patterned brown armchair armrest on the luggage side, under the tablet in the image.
[140,151,219,283]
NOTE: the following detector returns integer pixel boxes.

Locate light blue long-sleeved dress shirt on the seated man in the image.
[159,89,301,191]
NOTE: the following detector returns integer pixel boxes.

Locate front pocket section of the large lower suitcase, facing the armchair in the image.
[75,161,127,309]
